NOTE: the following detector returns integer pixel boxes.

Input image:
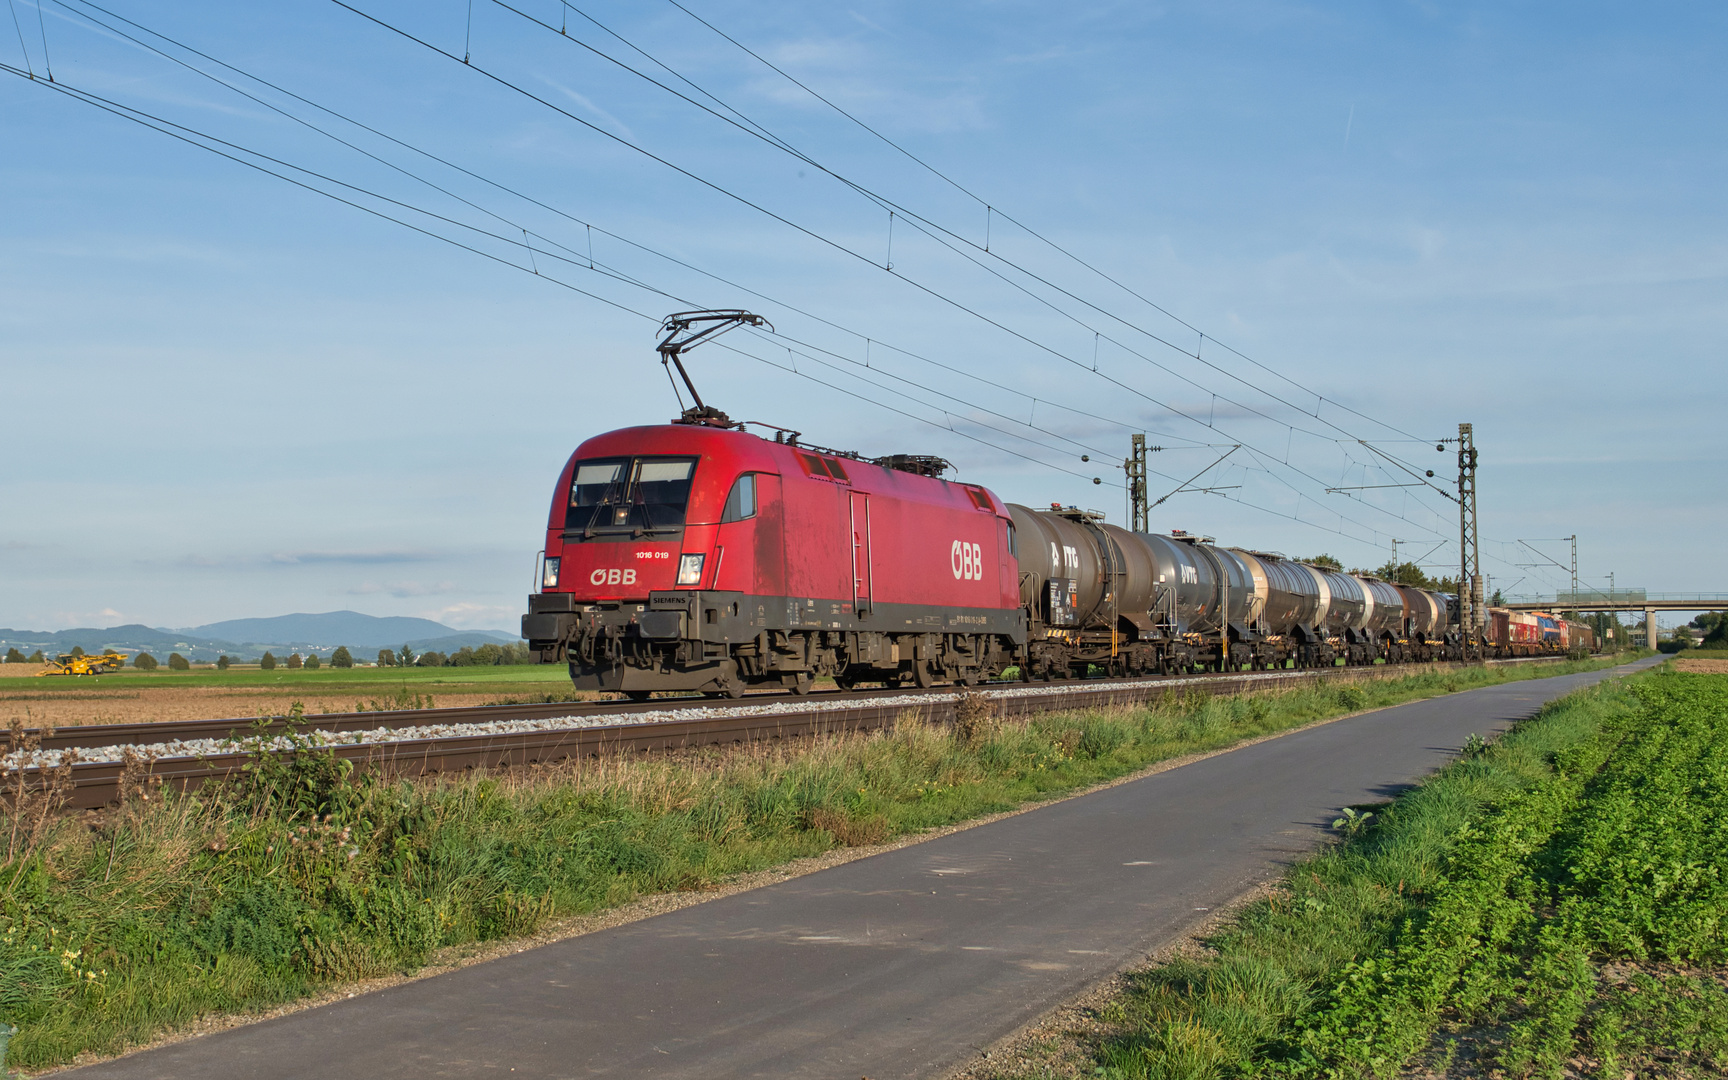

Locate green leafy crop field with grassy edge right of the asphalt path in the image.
[1009,656,1728,1080]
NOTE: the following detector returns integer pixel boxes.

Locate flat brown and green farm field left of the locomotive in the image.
[0,664,601,727]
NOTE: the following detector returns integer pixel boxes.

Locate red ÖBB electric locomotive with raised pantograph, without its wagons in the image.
[522,313,1025,698]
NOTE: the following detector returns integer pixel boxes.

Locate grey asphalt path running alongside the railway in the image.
[69,660,1655,1080]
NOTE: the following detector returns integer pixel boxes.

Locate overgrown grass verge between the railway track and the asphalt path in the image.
[0,662,1600,1068]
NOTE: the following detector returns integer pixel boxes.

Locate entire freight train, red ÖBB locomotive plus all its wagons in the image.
[522,313,1595,698]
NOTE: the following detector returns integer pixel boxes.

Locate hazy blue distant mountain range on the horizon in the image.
[0,612,517,660]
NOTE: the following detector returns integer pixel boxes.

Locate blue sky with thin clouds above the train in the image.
[0,0,1728,629]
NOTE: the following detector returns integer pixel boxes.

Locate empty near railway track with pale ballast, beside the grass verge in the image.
[10,657,1582,809]
